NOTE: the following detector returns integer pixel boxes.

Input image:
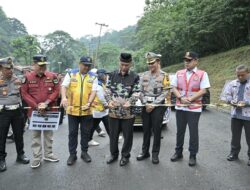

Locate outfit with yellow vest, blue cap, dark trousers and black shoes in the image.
[61,56,98,165]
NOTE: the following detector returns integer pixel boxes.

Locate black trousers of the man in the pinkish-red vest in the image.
[175,110,201,156]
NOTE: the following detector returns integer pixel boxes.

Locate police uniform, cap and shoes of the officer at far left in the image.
[0,57,29,172]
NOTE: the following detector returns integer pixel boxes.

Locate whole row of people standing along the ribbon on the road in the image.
[0,52,250,174]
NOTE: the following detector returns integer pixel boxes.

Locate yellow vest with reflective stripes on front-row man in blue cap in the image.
[67,72,96,116]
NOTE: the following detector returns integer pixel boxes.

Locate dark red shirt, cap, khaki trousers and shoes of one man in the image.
[21,55,60,168]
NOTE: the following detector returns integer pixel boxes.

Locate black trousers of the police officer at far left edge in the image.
[0,109,24,160]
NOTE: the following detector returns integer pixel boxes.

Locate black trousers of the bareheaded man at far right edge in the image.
[231,118,250,158]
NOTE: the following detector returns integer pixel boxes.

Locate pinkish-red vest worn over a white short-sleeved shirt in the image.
[176,69,205,110]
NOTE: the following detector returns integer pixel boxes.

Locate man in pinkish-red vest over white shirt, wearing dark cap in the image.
[171,52,210,166]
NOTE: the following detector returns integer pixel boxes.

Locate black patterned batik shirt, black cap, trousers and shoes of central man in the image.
[105,53,140,166]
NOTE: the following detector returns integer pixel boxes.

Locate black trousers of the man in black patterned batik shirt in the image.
[109,117,135,158]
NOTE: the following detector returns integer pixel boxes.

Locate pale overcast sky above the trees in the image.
[0,0,145,38]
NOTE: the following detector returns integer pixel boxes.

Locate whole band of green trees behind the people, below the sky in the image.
[0,0,250,71]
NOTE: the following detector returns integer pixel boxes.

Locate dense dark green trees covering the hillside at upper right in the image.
[136,0,250,65]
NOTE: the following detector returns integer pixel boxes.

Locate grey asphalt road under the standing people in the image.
[0,110,250,190]
